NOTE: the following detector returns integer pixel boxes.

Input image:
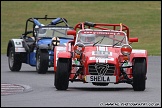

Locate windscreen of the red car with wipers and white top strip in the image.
[76,30,127,46]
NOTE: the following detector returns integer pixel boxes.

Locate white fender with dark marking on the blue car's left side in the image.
[7,39,26,56]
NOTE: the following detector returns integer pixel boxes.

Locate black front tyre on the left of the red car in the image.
[54,58,71,90]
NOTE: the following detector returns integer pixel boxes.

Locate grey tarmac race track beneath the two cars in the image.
[1,55,161,107]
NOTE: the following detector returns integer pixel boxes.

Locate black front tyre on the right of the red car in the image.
[133,58,147,91]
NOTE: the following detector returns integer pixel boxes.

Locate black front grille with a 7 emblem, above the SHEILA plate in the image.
[88,63,115,75]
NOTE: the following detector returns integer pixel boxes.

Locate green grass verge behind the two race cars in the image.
[1,1,161,55]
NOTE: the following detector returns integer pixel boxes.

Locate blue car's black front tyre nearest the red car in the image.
[36,50,49,74]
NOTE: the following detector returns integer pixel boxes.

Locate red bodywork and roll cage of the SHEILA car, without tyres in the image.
[54,22,148,85]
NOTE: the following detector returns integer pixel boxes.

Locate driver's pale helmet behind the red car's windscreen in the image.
[80,33,95,43]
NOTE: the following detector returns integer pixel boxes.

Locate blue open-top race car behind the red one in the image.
[7,15,74,74]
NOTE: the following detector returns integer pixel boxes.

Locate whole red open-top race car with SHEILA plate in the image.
[54,21,148,91]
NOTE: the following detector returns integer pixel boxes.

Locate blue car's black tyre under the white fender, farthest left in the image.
[8,47,22,71]
